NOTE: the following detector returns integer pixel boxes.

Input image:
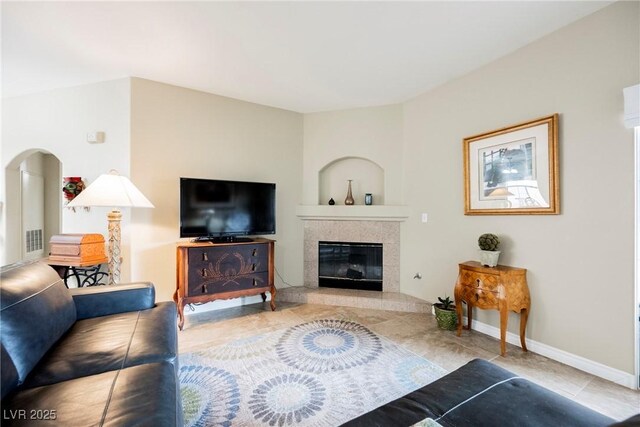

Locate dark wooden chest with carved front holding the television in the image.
[173,238,276,330]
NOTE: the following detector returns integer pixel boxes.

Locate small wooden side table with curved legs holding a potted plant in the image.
[454,261,531,356]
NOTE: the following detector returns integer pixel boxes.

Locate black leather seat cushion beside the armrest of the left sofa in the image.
[23,302,177,388]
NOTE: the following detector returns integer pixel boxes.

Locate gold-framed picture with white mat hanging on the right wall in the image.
[462,114,560,215]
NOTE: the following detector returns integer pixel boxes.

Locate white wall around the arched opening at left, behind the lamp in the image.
[0,79,130,280]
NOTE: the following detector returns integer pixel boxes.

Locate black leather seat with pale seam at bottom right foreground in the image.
[343,359,620,427]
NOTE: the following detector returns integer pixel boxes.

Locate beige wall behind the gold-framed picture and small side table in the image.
[401,2,640,373]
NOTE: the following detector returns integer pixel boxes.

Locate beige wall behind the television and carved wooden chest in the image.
[131,78,302,309]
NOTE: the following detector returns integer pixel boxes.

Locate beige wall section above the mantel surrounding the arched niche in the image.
[303,105,402,205]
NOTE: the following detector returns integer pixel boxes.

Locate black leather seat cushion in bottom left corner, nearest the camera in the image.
[2,362,182,427]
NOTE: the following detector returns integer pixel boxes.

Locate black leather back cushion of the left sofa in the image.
[0,262,76,383]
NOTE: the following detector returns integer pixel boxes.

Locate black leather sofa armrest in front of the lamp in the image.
[69,282,156,320]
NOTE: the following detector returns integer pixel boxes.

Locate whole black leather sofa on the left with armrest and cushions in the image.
[0,262,183,426]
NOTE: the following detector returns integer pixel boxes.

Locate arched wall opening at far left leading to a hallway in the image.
[0,148,62,265]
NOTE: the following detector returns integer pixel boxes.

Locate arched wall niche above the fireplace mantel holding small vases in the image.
[318,157,385,205]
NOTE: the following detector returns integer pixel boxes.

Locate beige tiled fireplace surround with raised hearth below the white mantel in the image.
[277,219,431,313]
